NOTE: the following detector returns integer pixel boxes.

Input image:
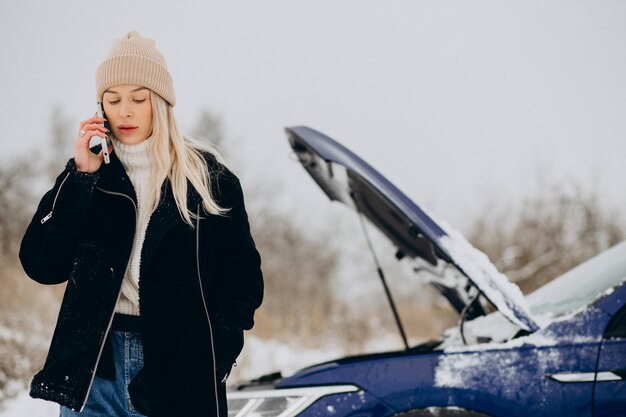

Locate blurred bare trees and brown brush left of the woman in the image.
[0,105,72,406]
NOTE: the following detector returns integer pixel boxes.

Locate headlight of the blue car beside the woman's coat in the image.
[227,385,359,417]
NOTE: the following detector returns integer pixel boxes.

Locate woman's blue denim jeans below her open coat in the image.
[60,331,145,417]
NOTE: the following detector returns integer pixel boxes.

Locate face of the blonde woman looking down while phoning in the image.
[102,84,152,145]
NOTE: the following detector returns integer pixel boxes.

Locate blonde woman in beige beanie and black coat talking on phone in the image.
[20,32,263,417]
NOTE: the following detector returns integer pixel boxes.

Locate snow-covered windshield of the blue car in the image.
[527,241,626,316]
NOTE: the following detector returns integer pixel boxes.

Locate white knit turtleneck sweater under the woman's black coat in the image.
[113,138,154,316]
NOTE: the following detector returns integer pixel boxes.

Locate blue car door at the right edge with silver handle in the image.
[594,306,626,417]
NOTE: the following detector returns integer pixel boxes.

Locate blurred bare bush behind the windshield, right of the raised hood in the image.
[468,181,626,292]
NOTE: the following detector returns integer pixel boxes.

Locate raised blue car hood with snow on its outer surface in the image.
[285,126,538,332]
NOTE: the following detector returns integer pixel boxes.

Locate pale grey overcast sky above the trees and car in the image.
[0,0,626,227]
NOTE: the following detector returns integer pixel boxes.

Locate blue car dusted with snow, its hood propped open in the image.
[228,127,626,417]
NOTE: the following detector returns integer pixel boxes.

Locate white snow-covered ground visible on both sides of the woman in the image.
[0,336,352,417]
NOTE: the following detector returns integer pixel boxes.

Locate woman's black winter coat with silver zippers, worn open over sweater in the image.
[20,153,263,417]
